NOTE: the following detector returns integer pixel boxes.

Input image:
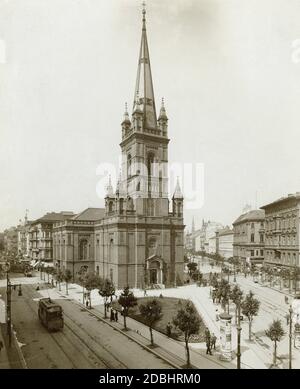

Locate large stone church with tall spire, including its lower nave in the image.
[54,9,185,288]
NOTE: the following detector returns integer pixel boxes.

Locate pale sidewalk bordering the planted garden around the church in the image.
[4,274,272,369]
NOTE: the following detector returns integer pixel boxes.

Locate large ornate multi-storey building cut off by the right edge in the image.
[261,192,300,268]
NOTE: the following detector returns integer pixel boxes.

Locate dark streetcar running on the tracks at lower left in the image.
[38,298,64,331]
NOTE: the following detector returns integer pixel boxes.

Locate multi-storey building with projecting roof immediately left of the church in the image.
[29,212,74,262]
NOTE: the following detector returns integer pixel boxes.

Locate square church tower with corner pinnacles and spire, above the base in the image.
[120,8,169,216]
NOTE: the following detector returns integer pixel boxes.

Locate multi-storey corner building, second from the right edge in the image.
[233,210,265,265]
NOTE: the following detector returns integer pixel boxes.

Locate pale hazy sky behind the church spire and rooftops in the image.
[0,0,300,230]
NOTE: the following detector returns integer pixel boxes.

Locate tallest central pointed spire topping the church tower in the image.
[133,4,157,128]
